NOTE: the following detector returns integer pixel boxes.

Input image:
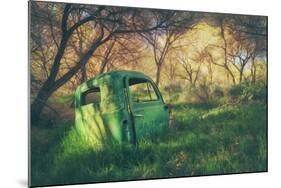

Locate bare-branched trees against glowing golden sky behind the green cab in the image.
[30,2,267,125]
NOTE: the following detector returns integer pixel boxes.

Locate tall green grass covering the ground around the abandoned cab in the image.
[32,102,267,185]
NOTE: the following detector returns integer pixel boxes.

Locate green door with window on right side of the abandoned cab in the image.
[128,78,169,141]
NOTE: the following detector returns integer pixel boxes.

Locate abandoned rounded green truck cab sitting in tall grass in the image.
[75,70,170,144]
